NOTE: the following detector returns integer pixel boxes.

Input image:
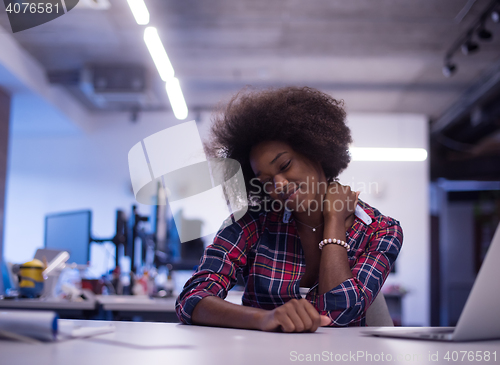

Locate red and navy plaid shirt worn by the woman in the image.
[175,201,403,326]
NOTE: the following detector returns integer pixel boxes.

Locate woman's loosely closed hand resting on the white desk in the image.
[259,299,332,332]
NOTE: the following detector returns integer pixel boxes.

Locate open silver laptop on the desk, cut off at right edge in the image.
[364,224,500,341]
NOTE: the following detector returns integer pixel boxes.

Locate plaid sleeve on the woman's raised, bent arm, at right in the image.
[316,220,403,326]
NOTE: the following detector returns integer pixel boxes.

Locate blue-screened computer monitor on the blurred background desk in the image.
[45,210,92,265]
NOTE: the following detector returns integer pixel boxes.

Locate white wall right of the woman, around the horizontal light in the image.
[340,114,430,326]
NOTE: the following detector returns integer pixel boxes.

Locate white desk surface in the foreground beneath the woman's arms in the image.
[0,320,500,365]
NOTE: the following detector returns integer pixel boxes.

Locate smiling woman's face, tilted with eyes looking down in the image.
[250,141,327,213]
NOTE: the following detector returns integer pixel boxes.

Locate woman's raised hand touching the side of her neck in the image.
[323,181,360,222]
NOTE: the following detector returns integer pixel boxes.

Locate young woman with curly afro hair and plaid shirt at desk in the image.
[176,87,403,332]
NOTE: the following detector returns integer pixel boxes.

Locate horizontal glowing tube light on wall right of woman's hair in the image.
[349,147,427,161]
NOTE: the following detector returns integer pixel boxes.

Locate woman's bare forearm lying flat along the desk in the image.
[192,296,267,329]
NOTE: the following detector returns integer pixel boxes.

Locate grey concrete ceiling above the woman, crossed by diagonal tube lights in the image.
[0,0,500,118]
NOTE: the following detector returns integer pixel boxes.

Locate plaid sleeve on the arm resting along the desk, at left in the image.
[175,213,259,324]
